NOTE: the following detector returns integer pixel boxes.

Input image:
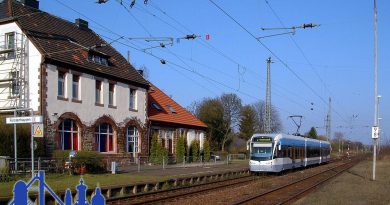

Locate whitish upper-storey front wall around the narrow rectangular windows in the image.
[46,64,146,126]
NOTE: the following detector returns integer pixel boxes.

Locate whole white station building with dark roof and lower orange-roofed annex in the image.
[0,0,206,159]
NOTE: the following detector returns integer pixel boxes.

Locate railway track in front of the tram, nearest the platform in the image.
[106,176,264,205]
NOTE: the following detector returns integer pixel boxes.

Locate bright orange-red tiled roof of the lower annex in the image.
[148,84,207,129]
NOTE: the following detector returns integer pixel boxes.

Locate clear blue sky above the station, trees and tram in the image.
[40,0,390,144]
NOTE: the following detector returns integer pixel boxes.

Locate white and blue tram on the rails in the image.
[248,133,331,172]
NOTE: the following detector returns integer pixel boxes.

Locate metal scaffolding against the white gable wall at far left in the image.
[0,32,29,110]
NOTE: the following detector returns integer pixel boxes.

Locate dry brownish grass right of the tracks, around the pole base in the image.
[295,155,390,205]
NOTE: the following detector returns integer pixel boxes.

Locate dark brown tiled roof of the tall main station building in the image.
[0,0,149,88]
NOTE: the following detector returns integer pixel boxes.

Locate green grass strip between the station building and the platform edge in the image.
[0,173,171,197]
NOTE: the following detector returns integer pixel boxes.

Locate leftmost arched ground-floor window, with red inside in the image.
[58,119,80,150]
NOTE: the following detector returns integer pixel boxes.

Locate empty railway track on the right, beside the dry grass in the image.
[231,159,360,205]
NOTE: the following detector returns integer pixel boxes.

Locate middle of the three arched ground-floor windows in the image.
[95,123,114,152]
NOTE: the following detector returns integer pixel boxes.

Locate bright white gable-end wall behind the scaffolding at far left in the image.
[0,22,41,111]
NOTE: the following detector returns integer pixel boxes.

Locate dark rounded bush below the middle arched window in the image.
[72,151,105,173]
